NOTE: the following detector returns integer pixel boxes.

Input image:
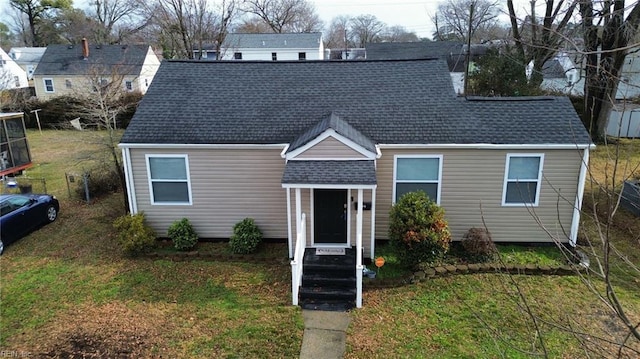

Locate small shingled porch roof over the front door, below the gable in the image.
[282,160,377,189]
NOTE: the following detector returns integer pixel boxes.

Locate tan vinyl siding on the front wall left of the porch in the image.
[131,148,287,238]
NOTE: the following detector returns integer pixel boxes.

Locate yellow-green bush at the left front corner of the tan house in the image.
[113,212,156,256]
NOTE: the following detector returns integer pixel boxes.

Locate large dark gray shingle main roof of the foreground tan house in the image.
[121,60,590,144]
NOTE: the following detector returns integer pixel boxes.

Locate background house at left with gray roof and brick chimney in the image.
[34,40,160,100]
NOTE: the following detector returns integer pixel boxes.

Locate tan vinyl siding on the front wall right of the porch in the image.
[376,149,582,242]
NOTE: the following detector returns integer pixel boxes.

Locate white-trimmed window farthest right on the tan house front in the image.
[502,153,544,206]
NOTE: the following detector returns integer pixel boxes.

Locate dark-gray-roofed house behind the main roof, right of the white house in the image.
[366,41,488,94]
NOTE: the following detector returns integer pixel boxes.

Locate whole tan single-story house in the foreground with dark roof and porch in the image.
[120,59,592,306]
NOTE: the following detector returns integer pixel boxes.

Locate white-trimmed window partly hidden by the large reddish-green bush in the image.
[393,155,442,204]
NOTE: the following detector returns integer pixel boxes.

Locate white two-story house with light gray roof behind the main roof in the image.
[195,32,324,61]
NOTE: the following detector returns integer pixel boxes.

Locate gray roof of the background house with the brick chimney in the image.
[34,44,149,75]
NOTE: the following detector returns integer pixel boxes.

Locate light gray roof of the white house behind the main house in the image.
[222,32,322,49]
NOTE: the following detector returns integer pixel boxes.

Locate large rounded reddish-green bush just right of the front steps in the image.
[389,191,451,267]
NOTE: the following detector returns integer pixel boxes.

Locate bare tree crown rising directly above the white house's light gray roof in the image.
[244,0,323,33]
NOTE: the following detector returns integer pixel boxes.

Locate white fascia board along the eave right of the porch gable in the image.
[378,143,596,150]
